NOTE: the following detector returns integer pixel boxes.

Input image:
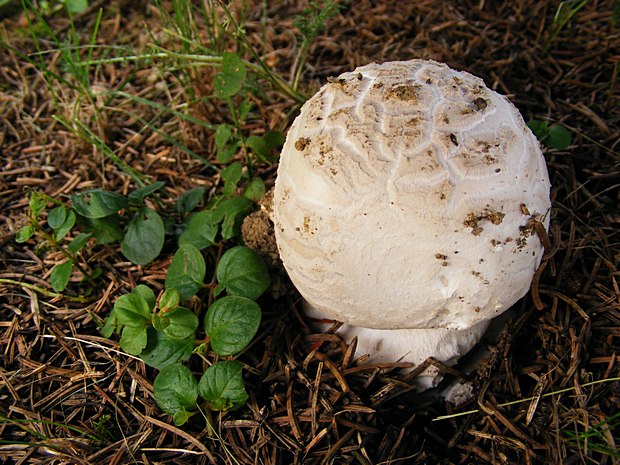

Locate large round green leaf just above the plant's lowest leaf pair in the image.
[204,296,261,356]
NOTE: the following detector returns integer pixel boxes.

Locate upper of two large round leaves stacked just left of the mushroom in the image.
[216,246,271,300]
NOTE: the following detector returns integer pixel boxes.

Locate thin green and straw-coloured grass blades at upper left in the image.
[9,0,318,180]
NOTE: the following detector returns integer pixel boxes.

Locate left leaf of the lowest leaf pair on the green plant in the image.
[153,363,198,426]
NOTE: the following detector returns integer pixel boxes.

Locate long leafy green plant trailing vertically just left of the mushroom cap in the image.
[92,47,283,425]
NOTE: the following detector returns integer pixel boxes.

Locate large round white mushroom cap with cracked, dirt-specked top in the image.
[273,60,551,329]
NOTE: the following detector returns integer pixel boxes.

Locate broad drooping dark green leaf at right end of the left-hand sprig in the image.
[121,207,166,265]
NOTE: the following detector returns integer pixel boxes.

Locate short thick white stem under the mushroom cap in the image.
[304,301,490,391]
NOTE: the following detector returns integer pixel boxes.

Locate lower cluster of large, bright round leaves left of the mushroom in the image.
[102,244,270,425]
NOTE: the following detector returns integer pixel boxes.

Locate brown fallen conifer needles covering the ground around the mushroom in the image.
[0,0,620,465]
